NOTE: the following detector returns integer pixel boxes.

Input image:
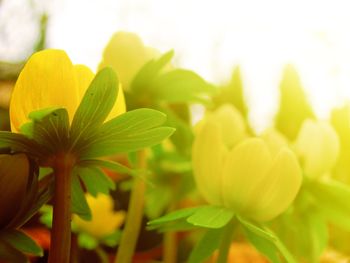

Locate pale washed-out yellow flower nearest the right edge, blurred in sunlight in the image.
[295,120,339,178]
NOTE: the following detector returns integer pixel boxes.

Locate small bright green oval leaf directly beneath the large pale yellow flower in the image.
[187,206,234,228]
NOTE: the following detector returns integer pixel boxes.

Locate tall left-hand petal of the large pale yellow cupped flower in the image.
[192,121,227,205]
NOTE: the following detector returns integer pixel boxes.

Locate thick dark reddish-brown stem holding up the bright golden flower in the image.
[49,154,75,263]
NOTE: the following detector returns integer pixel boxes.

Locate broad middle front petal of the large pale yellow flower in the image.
[222,138,272,215]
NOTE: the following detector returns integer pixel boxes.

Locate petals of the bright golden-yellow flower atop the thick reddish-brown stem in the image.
[10,49,125,132]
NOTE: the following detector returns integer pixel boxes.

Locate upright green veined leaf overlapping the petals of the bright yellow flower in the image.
[71,68,118,142]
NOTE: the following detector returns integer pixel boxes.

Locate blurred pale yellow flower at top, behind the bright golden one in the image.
[99,32,159,90]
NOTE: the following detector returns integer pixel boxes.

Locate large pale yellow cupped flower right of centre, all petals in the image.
[192,104,302,222]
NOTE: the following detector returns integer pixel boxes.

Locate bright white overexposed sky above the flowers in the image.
[0,0,350,129]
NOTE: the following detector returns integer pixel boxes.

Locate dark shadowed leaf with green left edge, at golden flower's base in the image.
[20,107,69,154]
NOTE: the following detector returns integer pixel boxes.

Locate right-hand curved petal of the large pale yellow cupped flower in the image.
[245,148,302,222]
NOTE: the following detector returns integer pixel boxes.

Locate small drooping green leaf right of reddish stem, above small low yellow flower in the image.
[76,167,115,197]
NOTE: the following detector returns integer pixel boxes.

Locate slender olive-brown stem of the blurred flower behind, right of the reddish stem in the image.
[114,150,147,263]
